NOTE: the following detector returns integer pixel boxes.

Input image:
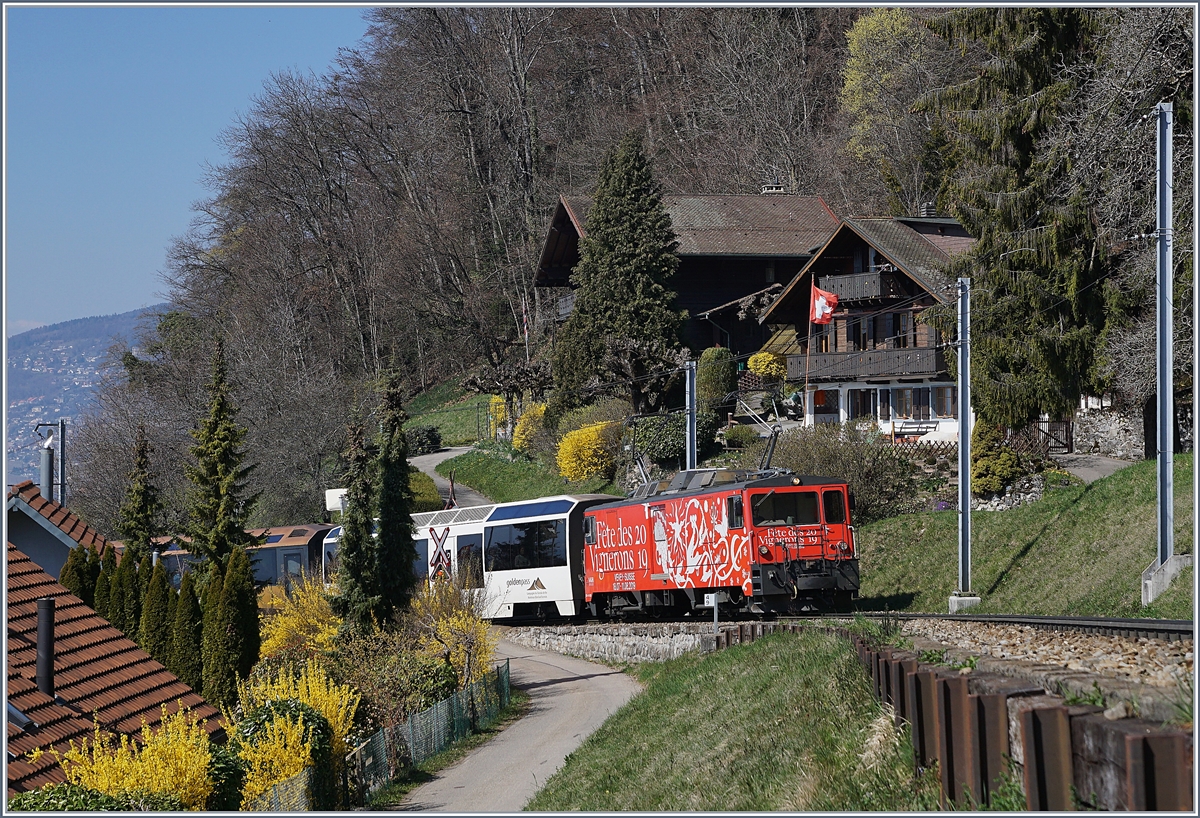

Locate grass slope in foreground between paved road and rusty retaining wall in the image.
[526,631,937,811]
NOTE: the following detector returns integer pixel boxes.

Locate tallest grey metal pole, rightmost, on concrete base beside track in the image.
[1157,102,1175,565]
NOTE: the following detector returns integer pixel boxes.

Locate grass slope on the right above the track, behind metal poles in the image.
[858,455,1194,619]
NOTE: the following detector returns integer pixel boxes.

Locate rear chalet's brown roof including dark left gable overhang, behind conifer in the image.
[535,193,838,287]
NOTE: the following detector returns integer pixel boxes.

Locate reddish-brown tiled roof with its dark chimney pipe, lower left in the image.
[5,542,224,794]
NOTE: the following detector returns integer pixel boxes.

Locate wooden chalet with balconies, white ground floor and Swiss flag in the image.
[760,217,974,439]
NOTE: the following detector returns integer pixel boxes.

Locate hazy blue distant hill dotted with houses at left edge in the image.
[5,303,167,486]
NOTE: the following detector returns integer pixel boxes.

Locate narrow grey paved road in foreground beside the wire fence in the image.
[395,639,641,813]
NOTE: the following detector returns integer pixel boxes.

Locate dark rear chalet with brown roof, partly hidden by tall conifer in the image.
[534,193,838,355]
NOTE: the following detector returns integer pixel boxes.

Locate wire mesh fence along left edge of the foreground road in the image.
[250,660,510,812]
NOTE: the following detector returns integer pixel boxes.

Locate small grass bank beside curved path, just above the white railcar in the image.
[437,446,623,503]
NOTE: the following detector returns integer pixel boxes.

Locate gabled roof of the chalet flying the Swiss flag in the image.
[758,218,974,323]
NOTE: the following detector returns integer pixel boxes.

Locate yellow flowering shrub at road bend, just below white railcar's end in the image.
[409,579,497,688]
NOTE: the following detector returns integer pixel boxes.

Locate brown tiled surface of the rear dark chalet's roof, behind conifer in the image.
[563,193,838,255]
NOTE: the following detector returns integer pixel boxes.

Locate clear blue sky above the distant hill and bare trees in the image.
[4,5,367,336]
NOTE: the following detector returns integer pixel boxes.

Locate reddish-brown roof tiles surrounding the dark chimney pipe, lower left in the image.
[6,542,224,790]
